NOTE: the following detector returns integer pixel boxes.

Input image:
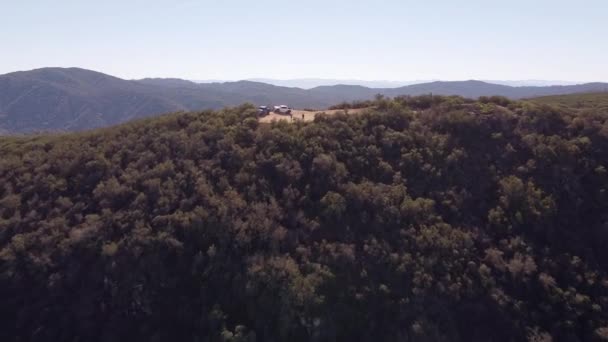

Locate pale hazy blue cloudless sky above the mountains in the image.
[0,0,608,81]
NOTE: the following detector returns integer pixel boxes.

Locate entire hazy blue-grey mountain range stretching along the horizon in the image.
[0,68,608,134]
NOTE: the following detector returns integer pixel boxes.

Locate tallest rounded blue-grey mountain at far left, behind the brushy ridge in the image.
[0,68,191,132]
